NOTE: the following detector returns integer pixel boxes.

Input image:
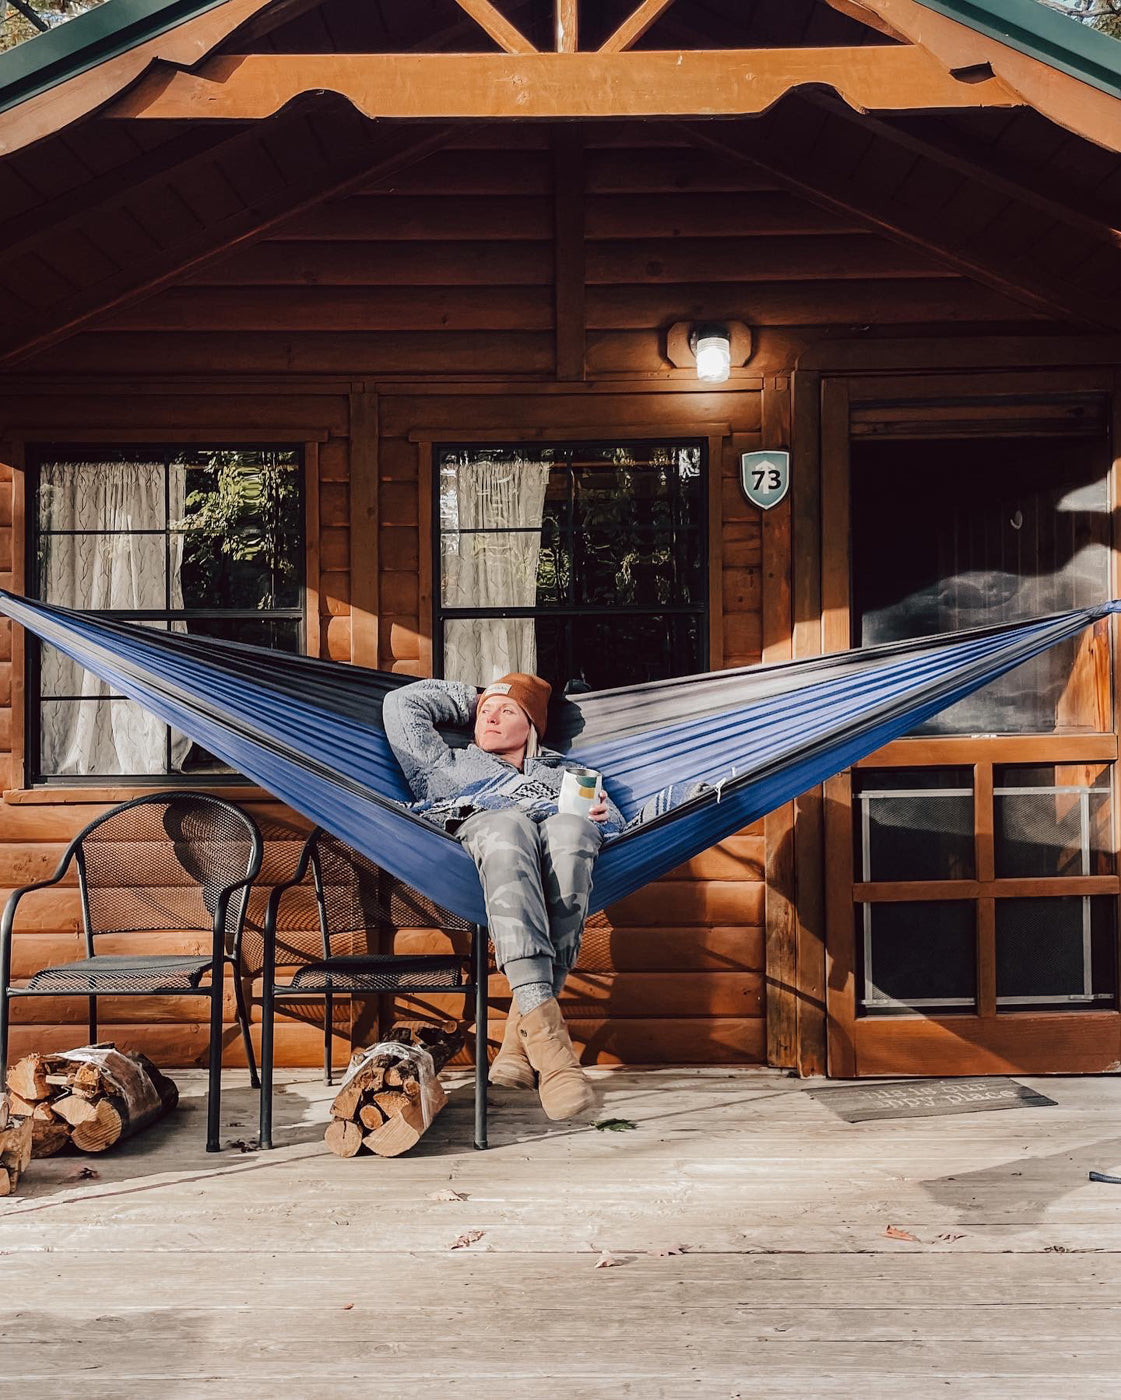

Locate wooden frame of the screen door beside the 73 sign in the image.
[820,370,1121,1078]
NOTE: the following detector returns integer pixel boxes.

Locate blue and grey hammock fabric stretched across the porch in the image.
[0,589,1121,923]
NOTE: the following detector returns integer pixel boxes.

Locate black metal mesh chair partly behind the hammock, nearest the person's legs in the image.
[260,827,490,1148]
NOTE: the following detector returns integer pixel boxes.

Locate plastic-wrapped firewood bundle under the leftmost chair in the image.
[8,1044,179,1156]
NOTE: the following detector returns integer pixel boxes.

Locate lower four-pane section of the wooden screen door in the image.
[852,763,1118,1015]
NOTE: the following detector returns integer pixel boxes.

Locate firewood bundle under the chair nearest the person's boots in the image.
[325,1026,463,1156]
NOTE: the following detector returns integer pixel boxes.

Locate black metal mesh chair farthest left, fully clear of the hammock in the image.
[0,791,262,1152]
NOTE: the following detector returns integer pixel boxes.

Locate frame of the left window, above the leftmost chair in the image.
[22,431,310,792]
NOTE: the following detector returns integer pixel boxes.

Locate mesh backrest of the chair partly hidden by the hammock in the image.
[308,829,473,956]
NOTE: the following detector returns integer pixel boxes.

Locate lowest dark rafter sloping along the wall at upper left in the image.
[0,113,449,364]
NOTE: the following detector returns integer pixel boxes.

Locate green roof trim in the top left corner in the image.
[0,0,225,112]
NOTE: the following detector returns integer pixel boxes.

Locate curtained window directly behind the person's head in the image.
[435,442,708,693]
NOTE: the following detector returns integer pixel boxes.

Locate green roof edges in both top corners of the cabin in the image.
[0,0,1121,121]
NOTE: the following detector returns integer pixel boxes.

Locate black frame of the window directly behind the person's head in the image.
[431,433,712,688]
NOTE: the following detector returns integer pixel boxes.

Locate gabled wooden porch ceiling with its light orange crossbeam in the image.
[0,0,1121,364]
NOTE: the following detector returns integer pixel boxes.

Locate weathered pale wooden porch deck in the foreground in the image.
[0,1068,1121,1400]
